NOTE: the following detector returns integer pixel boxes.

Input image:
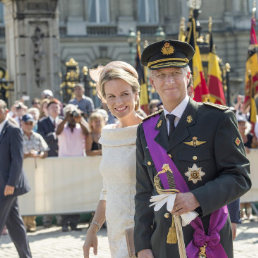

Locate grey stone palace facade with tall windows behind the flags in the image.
[0,0,255,105]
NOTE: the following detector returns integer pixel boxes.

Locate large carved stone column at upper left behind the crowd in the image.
[3,0,60,102]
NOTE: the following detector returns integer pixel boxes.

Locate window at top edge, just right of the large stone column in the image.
[88,0,109,23]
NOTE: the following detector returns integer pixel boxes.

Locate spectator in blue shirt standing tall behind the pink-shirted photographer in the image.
[69,83,94,118]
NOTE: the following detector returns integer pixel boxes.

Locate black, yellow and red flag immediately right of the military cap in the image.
[186,17,209,102]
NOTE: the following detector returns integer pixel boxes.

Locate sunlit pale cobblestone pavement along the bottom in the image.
[0,219,258,258]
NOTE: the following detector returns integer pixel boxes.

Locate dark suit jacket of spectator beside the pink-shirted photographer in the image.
[37,117,58,157]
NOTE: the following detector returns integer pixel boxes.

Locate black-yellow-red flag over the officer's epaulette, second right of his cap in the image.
[208,33,226,105]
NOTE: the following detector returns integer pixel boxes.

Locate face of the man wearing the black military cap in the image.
[150,67,188,106]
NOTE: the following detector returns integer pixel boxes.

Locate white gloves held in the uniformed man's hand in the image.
[150,194,198,227]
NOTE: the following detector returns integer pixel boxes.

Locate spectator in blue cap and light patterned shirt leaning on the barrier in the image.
[21,114,48,232]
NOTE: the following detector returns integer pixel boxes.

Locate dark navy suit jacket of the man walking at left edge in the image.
[0,121,30,198]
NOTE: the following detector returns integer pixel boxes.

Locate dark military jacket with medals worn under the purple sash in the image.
[134,100,251,258]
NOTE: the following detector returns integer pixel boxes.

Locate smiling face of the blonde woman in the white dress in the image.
[104,79,137,119]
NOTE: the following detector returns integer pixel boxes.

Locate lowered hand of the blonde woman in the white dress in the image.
[83,228,98,258]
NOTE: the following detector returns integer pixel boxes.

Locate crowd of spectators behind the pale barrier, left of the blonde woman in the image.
[2,83,115,234]
